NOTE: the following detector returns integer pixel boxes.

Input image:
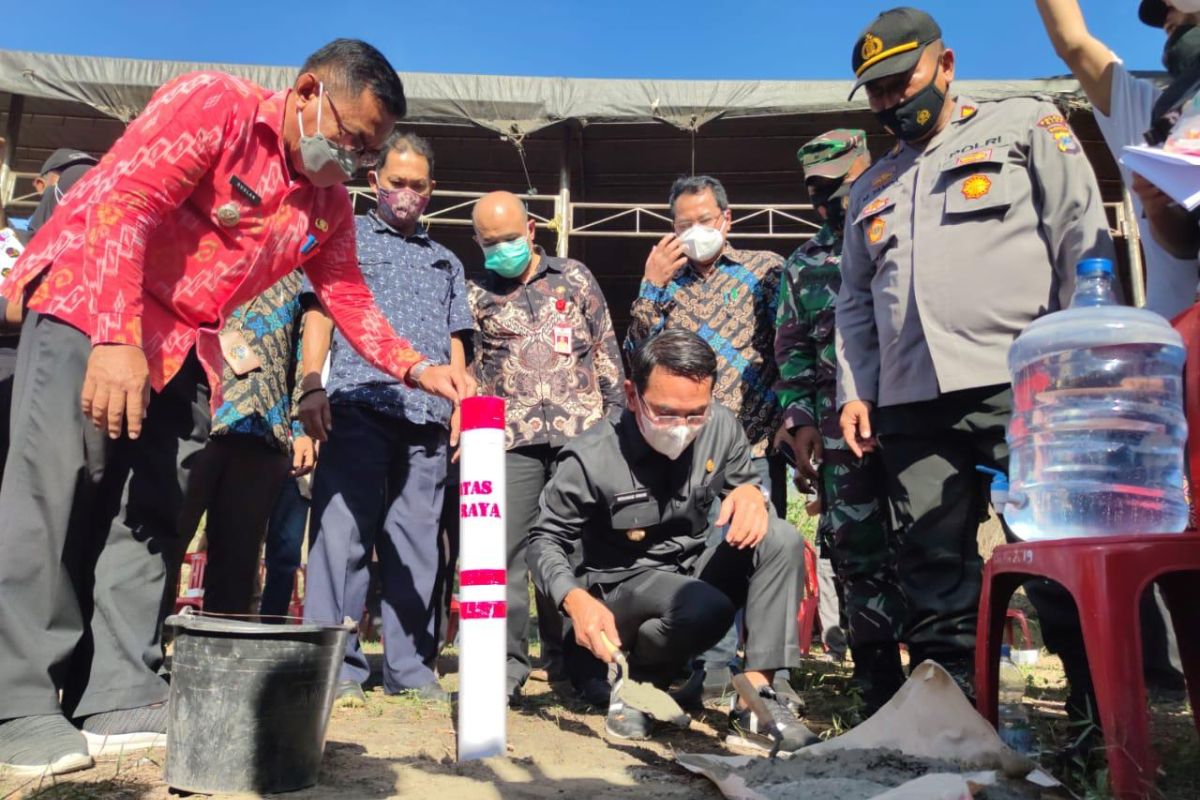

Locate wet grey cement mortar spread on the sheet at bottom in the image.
[738,750,1042,800]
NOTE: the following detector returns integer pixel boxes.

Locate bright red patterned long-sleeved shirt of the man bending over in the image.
[4,72,421,408]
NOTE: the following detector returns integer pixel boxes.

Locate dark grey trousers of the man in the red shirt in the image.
[0,314,210,720]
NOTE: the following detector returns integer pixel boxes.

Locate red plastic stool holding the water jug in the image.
[976,533,1200,800]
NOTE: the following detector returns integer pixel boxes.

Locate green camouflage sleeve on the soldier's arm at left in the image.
[775,251,818,431]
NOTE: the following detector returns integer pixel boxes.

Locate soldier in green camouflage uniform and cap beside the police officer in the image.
[775,130,906,711]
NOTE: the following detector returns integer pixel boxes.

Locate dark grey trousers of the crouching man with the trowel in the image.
[564,518,804,684]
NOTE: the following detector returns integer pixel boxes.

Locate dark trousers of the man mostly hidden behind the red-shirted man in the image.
[175,434,292,614]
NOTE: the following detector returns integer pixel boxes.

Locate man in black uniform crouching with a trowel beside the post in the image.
[529,330,815,750]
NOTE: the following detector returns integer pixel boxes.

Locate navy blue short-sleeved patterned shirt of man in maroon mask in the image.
[325,211,474,425]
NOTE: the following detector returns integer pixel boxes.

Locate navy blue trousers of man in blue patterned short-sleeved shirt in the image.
[304,403,450,693]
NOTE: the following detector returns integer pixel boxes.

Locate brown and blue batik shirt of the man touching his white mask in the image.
[625,247,784,458]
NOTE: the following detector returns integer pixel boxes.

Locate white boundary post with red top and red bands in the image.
[458,397,508,762]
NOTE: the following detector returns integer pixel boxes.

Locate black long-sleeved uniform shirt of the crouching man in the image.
[529,403,761,606]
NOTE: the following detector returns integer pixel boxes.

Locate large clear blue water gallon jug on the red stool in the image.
[1004,259,1188,540]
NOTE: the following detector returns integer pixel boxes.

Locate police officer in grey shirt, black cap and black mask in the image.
[836,8,1112,705]
